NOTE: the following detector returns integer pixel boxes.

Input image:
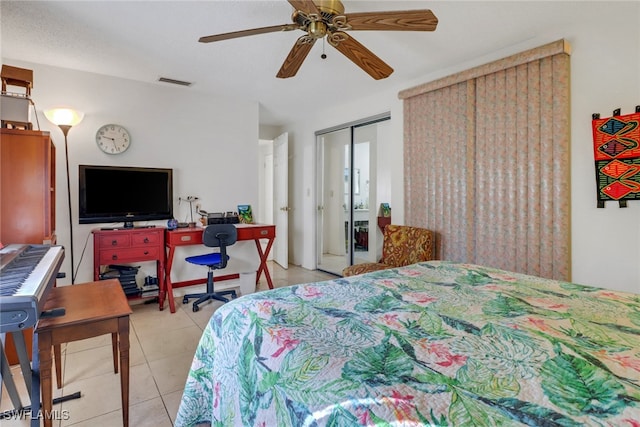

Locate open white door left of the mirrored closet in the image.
[273,132,290,268]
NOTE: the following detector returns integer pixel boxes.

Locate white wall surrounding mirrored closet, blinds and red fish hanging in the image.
[288,2,640,292]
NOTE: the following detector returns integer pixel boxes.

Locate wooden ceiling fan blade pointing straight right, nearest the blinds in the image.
[345,9,438,31]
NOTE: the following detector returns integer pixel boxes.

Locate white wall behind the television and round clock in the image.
[2,58,258,284]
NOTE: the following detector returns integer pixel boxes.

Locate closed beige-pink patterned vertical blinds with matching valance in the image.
[399,40,571,280]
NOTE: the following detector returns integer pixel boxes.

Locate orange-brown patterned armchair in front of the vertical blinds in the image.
[342,224,433,277]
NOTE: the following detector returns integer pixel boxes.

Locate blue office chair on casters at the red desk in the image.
[182,224,238,311]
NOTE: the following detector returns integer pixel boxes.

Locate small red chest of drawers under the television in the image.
[92,227,165,306]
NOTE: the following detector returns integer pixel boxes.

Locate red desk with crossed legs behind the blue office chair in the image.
[159,224,276,313]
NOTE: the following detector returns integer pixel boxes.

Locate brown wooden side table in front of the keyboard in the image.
[36,279,131,427]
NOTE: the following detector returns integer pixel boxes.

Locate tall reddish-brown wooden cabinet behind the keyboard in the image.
[0,129,56,245]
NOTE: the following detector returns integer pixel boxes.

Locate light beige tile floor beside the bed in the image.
[0,262,335,427]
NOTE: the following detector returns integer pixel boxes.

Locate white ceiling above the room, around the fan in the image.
[0,0,598,125]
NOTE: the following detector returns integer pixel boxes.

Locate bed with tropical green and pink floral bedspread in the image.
[175,261,640,427]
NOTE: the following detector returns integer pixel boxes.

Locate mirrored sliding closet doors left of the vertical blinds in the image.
[316,114,390,275]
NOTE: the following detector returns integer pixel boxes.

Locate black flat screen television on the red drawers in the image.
[78,165,173,228]
